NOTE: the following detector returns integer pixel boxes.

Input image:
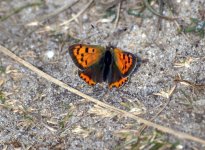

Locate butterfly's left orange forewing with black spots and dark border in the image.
[69,44,105,69]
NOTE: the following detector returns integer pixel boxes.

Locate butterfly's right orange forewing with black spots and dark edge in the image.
[114,48,136,77]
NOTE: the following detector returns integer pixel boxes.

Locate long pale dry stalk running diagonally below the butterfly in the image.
[0,45,205,144]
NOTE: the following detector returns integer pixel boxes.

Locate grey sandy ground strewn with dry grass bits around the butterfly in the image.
[0,0,205,150]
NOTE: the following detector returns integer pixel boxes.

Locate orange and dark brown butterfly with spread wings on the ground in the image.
[69,44,137,89]
